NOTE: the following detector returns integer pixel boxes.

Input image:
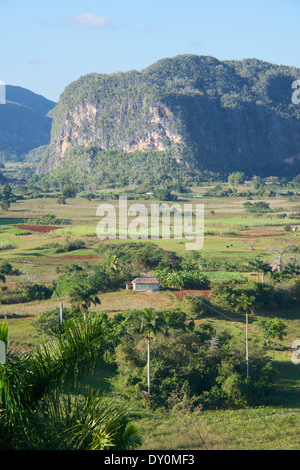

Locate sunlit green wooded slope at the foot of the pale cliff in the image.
[43,146,218,189]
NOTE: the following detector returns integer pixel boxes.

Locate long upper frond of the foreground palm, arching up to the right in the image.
[0,315,105,411]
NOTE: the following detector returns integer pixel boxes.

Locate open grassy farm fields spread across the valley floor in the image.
[0,182,300,450]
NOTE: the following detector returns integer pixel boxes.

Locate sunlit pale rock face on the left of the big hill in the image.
[40,74,182,172]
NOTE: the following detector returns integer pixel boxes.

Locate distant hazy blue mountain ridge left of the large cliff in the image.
[0,85,56,159]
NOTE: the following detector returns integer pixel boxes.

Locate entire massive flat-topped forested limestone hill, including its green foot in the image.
[40,54,299,184]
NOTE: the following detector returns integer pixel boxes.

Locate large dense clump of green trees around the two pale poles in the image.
[112,312,274,409]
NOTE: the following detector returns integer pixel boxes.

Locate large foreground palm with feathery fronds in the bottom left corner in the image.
[0,314,141,450]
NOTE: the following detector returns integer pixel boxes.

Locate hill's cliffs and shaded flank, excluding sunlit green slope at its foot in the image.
[39,55,300,176]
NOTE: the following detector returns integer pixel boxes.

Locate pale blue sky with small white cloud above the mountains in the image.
[0,0,300,101]
